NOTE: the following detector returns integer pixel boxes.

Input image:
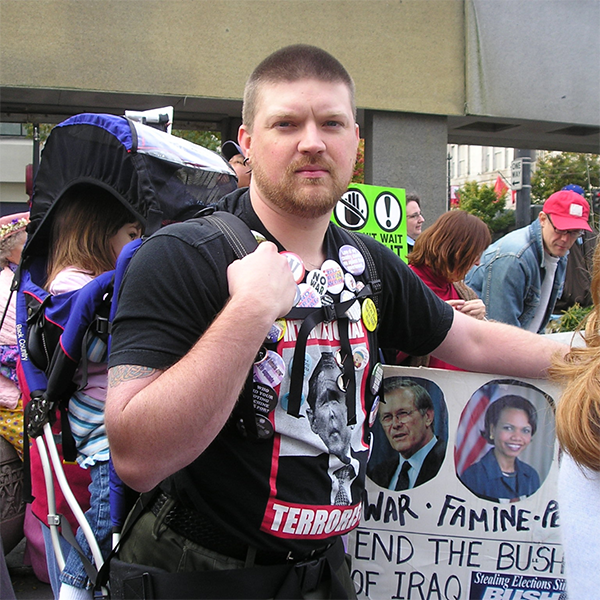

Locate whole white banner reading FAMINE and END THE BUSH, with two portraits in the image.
[347,367,566,600]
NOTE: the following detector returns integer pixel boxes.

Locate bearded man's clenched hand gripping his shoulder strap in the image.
[227,242,297,321]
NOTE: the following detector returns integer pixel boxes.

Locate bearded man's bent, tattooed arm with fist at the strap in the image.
[105,242,296,491]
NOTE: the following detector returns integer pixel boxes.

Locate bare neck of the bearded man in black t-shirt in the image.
[250,187,331,271]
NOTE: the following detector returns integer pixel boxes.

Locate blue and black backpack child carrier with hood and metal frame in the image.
[13,114,237,581]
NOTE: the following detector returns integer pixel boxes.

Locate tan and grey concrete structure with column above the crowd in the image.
[0,0,600,222]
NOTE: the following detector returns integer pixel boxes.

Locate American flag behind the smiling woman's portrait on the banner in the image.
[454,384,494,477]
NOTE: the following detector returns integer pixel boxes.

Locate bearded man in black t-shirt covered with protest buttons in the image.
[106,45,565,600]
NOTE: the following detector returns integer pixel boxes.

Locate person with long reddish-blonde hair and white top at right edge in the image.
[550,237,600,600]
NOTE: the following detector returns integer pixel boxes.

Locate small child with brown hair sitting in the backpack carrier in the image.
[46,186,141,600]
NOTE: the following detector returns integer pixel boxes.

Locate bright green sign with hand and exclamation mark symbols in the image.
[332,183,407,261]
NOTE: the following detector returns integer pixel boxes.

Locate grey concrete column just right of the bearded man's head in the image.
[361,111,448,227]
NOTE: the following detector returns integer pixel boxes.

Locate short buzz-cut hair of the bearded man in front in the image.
[242,44,356,130]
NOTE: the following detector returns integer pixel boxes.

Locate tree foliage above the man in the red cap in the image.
[531,152,600,204]
